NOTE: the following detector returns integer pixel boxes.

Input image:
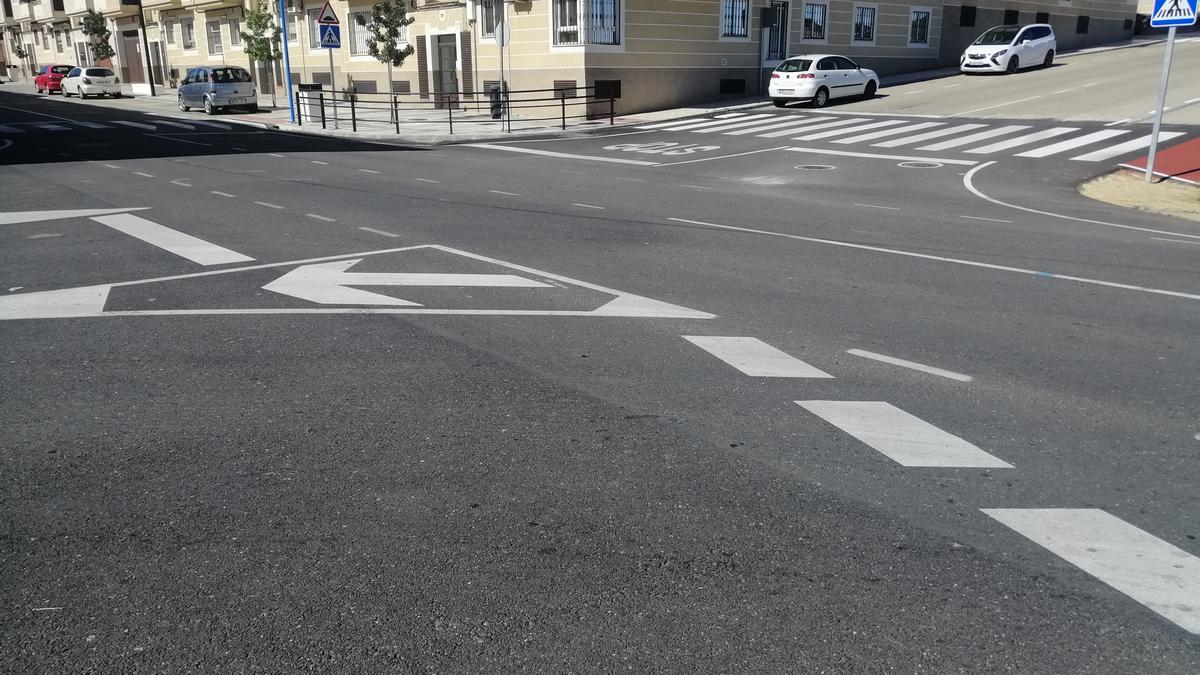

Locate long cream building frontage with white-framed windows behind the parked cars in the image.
[0,0,1138,113]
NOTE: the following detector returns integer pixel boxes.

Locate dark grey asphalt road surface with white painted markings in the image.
[7,92,1200,673]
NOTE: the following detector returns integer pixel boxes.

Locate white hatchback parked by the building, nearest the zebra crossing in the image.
[767,54,880,108]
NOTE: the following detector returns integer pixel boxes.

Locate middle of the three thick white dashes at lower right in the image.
[796,401,1013,468]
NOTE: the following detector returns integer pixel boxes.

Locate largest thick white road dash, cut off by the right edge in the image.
[982,508,1200,634]
